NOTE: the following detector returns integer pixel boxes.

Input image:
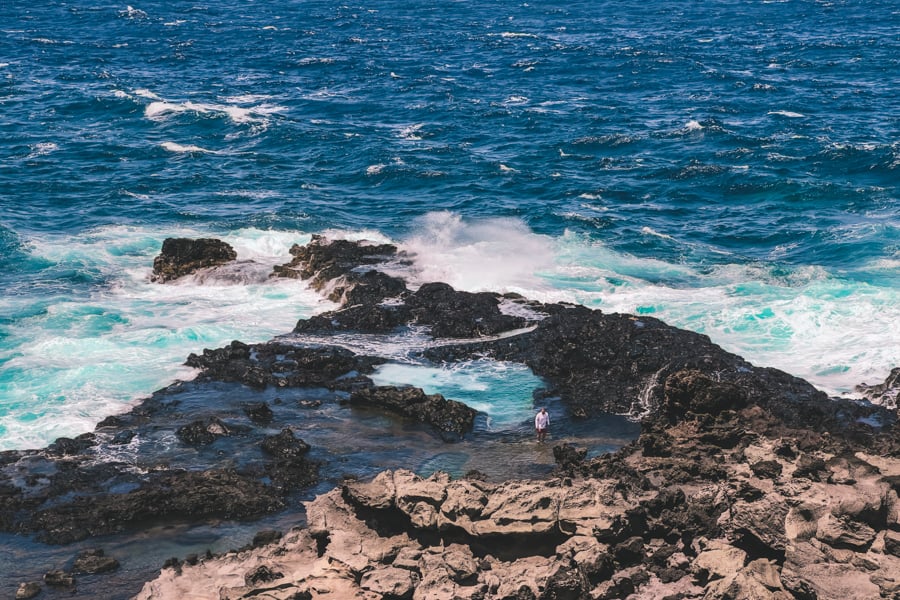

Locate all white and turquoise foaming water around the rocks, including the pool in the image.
[0,213,900,449]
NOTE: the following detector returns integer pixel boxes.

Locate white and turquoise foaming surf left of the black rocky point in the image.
[0,227,333,449]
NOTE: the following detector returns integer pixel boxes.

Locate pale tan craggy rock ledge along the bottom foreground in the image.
[138,441,900,600]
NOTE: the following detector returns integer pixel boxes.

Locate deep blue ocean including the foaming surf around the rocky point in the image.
[0,0,900,449]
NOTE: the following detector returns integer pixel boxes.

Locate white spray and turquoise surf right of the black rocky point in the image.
[401,212,900,394]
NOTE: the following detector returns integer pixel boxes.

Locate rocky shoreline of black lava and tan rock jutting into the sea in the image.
[0,237,900,600]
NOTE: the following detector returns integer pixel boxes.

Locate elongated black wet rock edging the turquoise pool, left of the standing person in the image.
[350,386,477,439]
